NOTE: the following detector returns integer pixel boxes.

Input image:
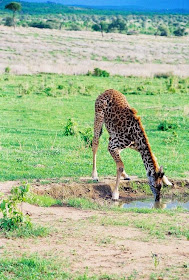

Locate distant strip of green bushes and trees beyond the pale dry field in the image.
[2,2,189,36]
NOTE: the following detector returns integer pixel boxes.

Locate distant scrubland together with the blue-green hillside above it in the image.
[0,1,189,36]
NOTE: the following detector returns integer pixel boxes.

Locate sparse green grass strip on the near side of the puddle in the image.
[62,198,189,240]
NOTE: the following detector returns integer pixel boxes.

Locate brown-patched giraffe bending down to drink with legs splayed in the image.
[92,89,172,201]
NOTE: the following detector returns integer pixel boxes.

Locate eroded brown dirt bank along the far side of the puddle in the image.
[32,177,189,200]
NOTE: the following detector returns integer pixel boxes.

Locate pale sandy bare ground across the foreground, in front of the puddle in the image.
[0,204,189,280]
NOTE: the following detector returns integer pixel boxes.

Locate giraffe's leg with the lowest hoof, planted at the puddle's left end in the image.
[108,144,127,200]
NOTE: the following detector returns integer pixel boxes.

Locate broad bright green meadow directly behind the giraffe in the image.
[0,74,189,181]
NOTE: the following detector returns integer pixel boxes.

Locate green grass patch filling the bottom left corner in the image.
[0,256,127,280]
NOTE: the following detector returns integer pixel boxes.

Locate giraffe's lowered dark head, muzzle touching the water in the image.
[147,166,164,201]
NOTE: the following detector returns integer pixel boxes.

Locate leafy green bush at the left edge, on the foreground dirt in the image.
[0,185,31,231]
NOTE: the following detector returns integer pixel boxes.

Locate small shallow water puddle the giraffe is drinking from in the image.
[122,197,189,210]
